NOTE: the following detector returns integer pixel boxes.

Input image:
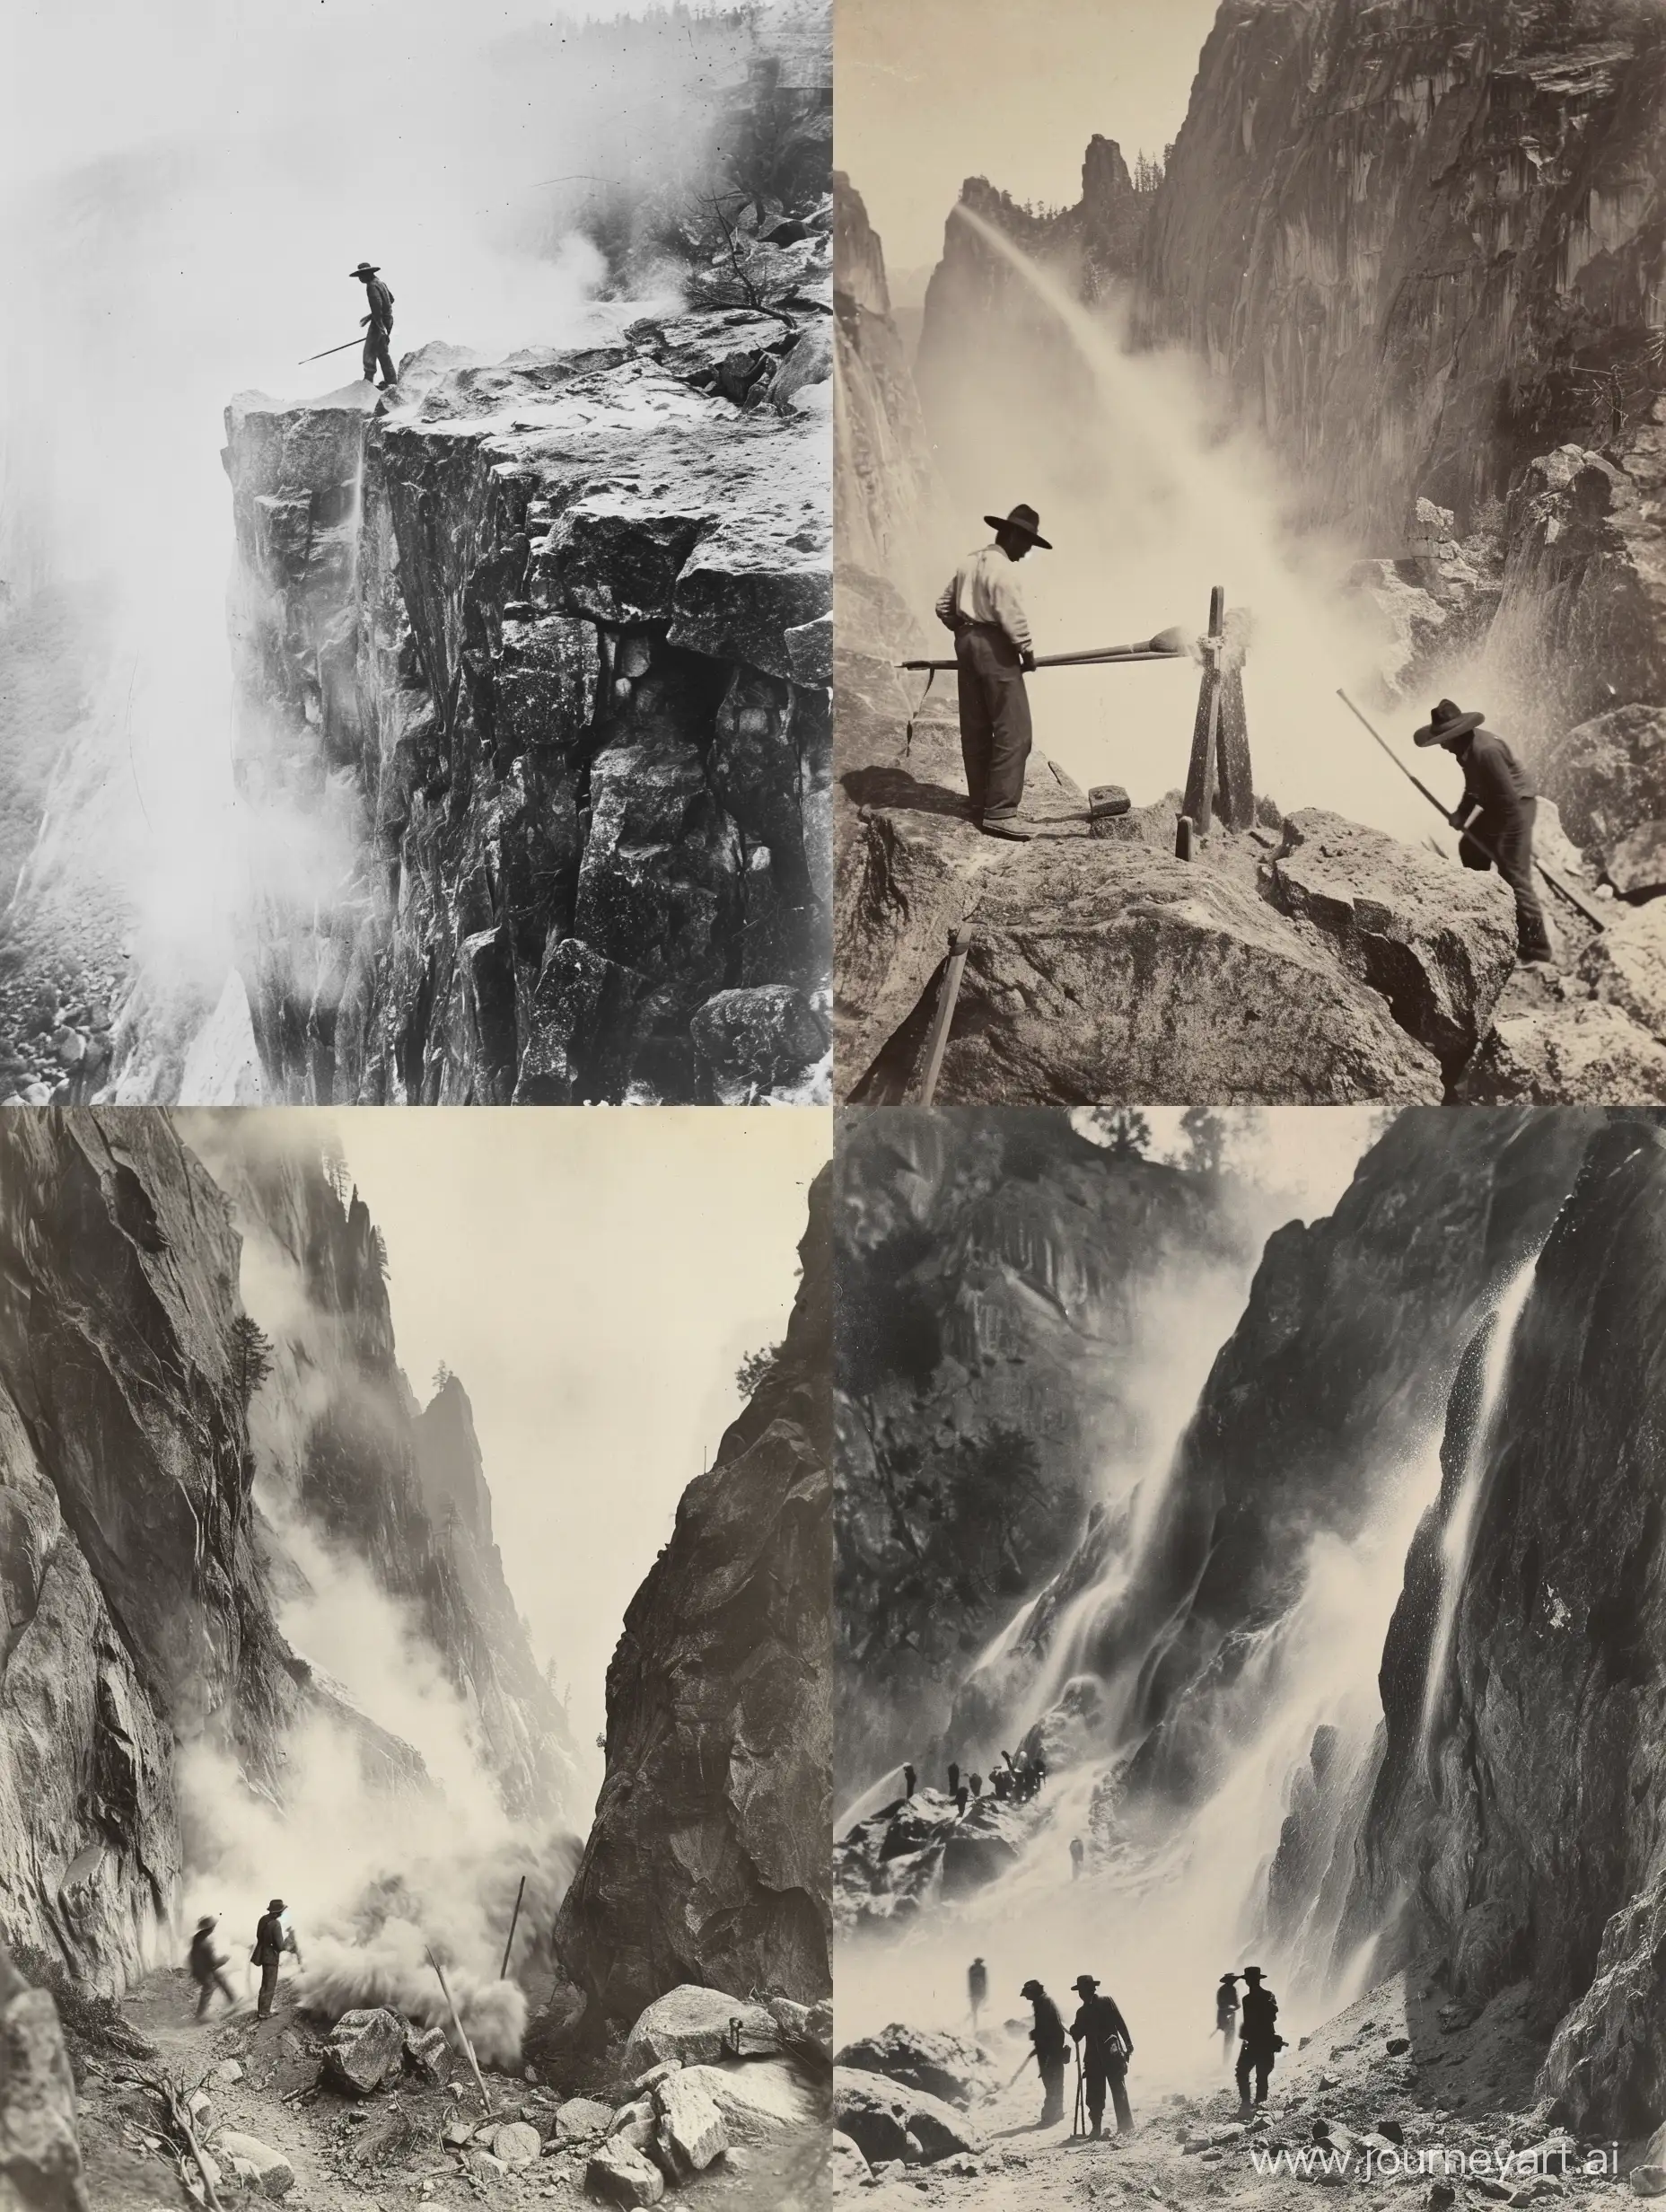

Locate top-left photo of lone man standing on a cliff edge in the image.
[0,0,832,1106]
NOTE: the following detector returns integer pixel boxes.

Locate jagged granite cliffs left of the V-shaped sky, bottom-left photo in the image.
[0,1108,573,1991]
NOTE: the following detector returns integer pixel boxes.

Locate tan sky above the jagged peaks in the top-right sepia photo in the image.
[834,0,1214,270]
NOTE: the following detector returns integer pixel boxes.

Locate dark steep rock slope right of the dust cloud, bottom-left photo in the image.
[544,1170,832,2050]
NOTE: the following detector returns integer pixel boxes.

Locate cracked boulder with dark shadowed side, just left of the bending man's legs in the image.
[1272,807,1515,1075]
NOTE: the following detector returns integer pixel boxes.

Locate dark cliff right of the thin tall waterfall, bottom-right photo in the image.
[1356,1115,1666,2137]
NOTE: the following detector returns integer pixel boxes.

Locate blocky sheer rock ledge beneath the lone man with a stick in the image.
[225,301,832,1104]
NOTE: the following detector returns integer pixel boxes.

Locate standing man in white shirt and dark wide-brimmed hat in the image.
[938,506,1051,843]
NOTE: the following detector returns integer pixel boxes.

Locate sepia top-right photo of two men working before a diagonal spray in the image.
[834,0,1666,1108]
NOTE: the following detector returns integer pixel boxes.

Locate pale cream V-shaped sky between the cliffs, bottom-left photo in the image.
[334,1106,832,1741]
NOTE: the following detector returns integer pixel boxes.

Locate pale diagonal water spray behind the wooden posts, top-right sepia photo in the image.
[941,206,1458,840]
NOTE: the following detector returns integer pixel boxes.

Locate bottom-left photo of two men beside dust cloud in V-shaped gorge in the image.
[0,1108,832,2212]
